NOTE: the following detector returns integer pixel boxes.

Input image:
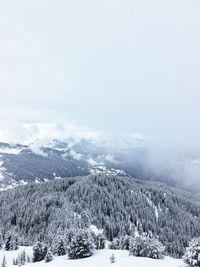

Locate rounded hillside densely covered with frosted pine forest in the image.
[0,174,200,257]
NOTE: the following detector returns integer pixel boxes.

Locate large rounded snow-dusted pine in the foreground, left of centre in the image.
[68,230,95,259]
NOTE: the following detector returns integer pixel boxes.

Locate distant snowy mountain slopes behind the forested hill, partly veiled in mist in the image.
[0,138,200,191]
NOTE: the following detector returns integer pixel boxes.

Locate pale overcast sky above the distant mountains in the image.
[0,0,200,146]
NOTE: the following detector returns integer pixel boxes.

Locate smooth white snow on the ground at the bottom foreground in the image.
[0,247,184,267]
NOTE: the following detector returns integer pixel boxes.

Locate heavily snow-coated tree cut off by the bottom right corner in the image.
[183,238,200,267]
